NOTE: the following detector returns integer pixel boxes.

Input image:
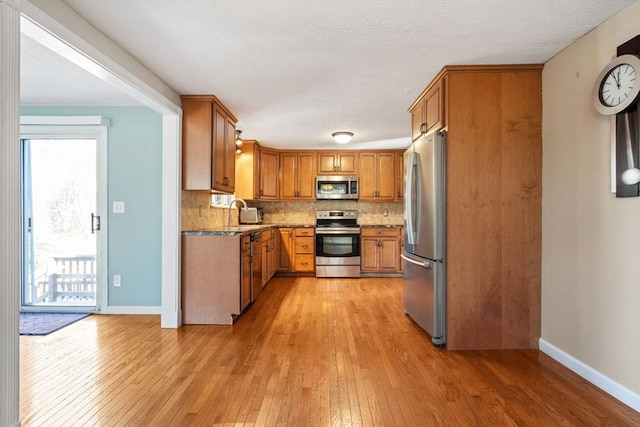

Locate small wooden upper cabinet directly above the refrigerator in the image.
[409,79,445,141]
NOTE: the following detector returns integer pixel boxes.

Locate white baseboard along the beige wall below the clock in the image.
[539,338,640,412]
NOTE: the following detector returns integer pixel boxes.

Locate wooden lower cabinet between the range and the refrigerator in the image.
[360,227,402,273]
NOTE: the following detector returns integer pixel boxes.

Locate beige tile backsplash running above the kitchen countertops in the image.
[182,190,403,231]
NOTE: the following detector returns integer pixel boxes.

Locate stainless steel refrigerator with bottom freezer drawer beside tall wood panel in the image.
[402,132,446,346]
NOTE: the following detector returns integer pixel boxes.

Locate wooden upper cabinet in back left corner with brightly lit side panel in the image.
[236,140,279,200]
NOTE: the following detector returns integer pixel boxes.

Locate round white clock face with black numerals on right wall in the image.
[593,54,640,115]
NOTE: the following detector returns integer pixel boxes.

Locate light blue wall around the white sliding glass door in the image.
[21,107,162,306]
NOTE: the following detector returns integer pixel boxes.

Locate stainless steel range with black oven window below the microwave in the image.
[316,210,360,277]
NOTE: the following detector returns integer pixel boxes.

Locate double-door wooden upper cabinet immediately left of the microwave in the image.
[279,151,316,200]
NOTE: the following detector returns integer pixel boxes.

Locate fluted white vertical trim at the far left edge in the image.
[0,0,22,427]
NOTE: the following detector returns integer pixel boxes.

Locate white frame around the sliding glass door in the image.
[20,116,109,313]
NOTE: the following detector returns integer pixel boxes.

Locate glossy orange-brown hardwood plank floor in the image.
[20,278,640,426]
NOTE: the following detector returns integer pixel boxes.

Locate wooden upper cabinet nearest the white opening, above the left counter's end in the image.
[181,95,238,193]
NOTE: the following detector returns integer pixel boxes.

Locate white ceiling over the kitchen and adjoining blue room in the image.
[21,0,633,148]
